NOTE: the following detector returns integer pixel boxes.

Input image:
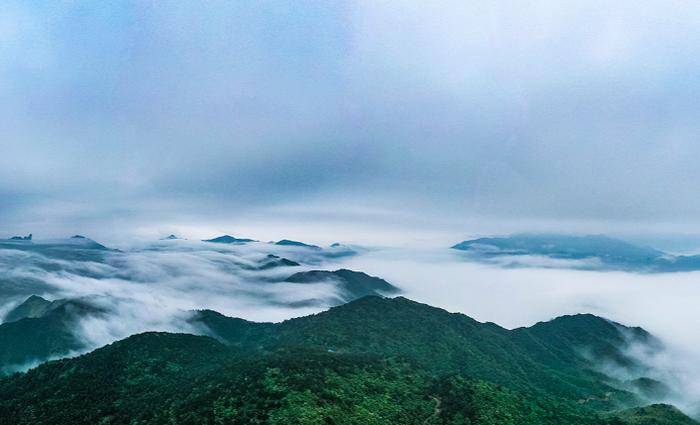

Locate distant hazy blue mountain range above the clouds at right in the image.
[452,234,700,272]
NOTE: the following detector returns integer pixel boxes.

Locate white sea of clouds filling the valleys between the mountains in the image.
[0,240,700,412]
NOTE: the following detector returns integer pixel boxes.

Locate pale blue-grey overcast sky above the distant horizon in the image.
[0,0,700,245]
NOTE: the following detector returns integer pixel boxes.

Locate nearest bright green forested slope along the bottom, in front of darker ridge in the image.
[0,333,620,425]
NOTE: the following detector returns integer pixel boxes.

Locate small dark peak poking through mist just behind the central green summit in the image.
[286,269,399,302]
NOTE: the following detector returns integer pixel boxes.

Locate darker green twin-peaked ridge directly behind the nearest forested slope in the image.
[193,297,635,409]
